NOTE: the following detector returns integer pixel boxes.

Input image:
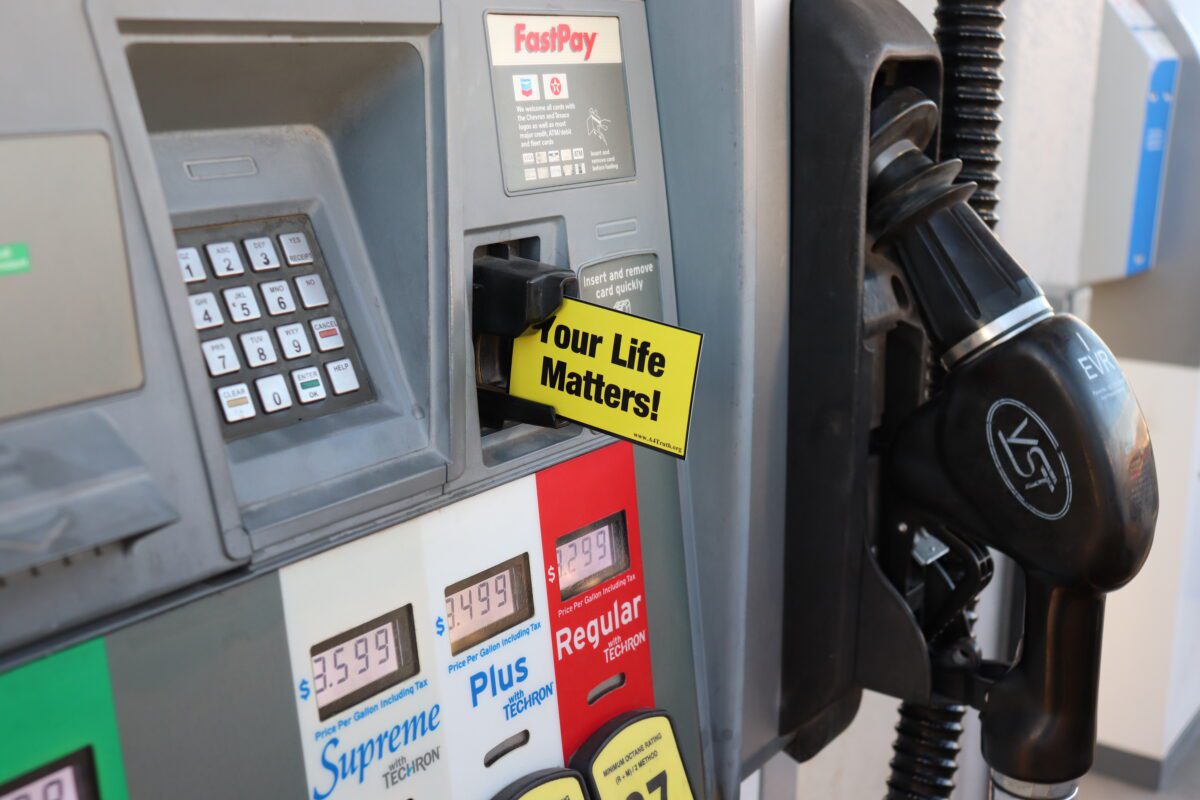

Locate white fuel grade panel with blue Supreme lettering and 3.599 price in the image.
[280,515,451,800]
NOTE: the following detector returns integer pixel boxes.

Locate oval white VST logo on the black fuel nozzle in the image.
[988,398,1070,521]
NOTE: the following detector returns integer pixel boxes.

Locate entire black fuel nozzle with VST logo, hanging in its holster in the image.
[868,90,1158,798]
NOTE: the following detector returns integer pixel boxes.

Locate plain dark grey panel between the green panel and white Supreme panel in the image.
[106,573,307,800]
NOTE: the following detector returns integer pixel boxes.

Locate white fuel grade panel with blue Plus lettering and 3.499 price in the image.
[421,477,563,798]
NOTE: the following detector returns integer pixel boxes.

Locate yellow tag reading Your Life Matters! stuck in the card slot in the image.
[509,300,702,458]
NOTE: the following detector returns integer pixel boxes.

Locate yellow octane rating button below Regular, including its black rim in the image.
[571,710,694,800]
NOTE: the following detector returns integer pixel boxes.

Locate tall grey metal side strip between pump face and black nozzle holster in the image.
[647,0,799,798]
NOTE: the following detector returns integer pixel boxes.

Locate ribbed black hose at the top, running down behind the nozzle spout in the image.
[934,0,1004,228]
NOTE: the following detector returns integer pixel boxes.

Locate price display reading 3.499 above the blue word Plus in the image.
[445,553,533,655]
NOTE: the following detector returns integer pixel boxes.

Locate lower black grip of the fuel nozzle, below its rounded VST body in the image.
[980,572,1104,783]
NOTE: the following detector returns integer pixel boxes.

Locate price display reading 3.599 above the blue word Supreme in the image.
[310,604,420,720]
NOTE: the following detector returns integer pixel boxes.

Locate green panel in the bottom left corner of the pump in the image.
[0,639,128,800]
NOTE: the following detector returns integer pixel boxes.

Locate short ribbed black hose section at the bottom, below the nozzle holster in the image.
[887,703,966,800]
